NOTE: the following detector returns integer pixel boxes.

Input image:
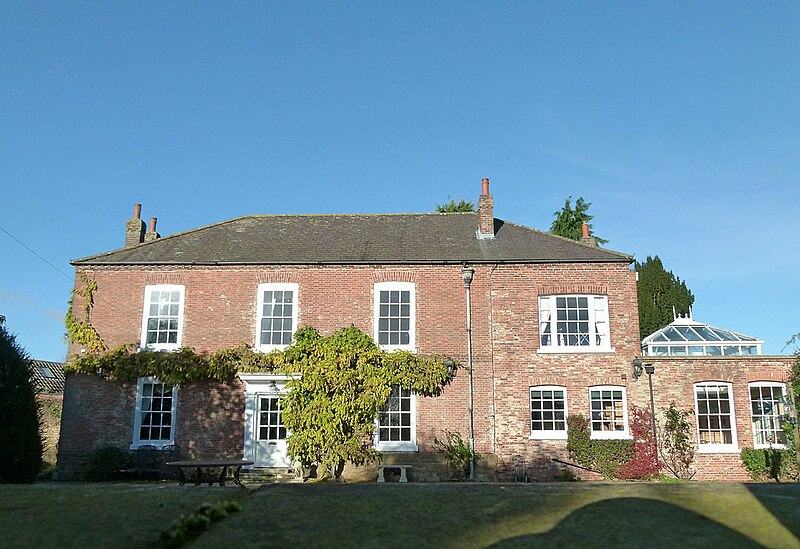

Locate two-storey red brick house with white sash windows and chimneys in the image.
[58,179,789,480]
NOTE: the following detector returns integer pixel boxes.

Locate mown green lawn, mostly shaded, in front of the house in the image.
[0,483,800,548]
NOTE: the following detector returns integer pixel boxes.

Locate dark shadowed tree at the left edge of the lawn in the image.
[0,318,42,483]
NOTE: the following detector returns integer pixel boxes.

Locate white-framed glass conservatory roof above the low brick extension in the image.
[642,310,764,356]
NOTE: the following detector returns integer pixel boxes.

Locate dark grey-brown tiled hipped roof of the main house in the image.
[72,213,632,265]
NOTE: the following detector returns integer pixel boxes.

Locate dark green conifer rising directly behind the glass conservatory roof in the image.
[635,256,694,339]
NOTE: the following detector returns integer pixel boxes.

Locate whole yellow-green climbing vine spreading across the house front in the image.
[65,316,449,478]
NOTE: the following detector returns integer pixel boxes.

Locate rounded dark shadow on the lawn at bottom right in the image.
[492,497,761,549]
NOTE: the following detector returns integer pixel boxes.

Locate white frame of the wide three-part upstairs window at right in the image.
[538,294,614,353]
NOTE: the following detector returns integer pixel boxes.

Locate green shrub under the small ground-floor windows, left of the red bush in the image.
[567,414,634,479]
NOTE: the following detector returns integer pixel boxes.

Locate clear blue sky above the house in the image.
[0,0,800,360]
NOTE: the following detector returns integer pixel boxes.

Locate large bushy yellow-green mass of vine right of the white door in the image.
[274,326,449,478]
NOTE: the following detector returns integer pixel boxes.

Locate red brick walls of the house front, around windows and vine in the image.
[59,264,788,478]
